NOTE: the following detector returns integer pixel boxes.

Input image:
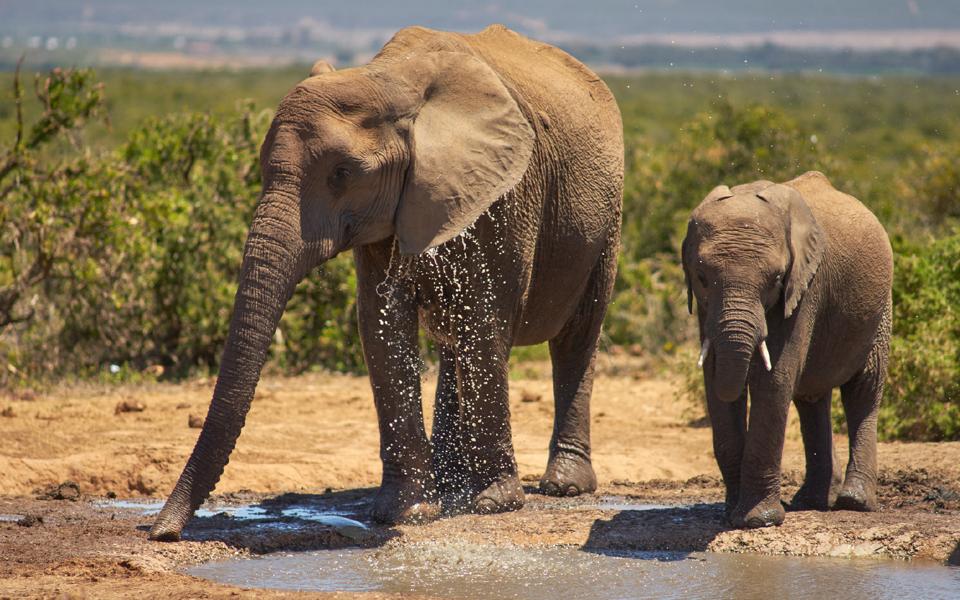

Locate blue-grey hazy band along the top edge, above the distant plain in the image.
[0,0,960,37]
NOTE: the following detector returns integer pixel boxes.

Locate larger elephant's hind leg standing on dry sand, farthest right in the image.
[540,241,617,496]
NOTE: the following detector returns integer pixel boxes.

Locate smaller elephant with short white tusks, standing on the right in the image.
[683,171,893,527]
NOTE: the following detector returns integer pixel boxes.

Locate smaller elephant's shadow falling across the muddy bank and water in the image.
[581,503,729,561]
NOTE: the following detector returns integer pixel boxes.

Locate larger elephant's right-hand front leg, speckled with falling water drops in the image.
[456,336,524,513]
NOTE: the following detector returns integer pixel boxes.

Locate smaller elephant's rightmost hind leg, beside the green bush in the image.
[835,308,891,511]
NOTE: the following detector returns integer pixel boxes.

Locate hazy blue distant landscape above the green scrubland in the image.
[0,0,960,74]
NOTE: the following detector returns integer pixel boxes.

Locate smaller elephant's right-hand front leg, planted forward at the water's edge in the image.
[730,389,793,528]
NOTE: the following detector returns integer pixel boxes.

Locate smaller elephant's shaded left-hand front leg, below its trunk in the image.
[704,382,747,519]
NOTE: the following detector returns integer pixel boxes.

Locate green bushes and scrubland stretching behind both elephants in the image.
[0,64,960,439]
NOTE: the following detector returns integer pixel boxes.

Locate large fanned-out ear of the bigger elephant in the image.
[394,51,534,254]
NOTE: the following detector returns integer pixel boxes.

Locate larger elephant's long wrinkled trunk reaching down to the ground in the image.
[150,202,306,541]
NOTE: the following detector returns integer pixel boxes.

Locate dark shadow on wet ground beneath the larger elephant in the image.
[138,488,399,554]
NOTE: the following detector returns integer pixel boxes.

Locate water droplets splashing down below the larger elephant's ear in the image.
[376,200,516,502]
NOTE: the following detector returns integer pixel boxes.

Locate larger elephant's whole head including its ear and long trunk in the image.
[150,51,534,540]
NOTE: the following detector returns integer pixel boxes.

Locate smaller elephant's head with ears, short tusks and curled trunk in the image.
[683,181,825,401]
